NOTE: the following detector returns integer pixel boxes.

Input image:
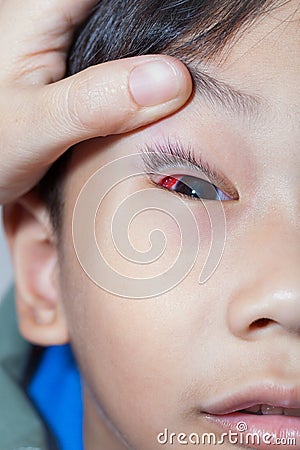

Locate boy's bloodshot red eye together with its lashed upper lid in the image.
[141,140,239,201]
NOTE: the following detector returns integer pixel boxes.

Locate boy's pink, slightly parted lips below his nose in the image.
[202,384,300,450]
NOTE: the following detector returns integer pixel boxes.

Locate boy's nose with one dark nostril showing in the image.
[227,209,300,339]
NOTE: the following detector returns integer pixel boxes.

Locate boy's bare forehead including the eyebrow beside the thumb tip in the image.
[188,1,300,115]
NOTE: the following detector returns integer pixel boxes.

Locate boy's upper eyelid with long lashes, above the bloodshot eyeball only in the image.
[140,140,239,199]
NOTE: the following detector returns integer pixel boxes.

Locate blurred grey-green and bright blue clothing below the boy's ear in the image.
[0,290,82,450]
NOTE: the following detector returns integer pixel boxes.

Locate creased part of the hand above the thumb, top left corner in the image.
[0,0,96,84]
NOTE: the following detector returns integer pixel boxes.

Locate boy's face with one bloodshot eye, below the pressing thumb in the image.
[8,2,300,450]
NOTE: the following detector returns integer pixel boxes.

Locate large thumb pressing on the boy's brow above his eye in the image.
[0,55,192,203]
